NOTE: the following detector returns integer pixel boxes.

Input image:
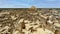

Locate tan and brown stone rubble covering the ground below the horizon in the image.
[0,10,60,34]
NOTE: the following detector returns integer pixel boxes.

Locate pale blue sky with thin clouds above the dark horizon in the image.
[0,0,60,8]
